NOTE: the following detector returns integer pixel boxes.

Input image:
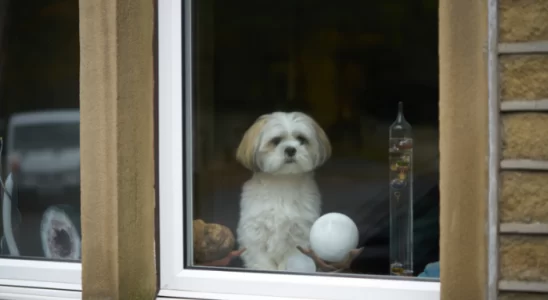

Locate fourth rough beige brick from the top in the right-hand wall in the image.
[500,172,548,223]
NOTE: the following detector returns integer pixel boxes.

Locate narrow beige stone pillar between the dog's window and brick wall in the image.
[439,0,488,300]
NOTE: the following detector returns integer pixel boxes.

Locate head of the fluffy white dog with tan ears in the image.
[236,112,331,174]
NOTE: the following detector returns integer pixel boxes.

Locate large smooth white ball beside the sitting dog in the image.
[310,213,359,262]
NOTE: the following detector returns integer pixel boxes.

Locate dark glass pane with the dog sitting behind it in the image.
[191,0,439,278]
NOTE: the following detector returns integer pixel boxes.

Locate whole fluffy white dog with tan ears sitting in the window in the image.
[236,112,331,270]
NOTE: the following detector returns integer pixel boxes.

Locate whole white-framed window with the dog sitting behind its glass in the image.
[158,0,439,299]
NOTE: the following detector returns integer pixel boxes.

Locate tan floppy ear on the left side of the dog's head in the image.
[236,115,270,171]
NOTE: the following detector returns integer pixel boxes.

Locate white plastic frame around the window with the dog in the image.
[157,0,440,300]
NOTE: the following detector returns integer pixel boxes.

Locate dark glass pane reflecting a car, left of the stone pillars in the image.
[0,0,81,261]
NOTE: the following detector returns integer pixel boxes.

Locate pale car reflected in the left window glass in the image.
[6,110,80,211]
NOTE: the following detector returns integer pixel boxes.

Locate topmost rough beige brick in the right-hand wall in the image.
[499,0,548,42]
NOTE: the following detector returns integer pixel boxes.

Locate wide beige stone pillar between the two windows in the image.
[79,0,157,300]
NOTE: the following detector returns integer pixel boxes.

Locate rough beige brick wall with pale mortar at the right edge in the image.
[499,0,548,300]
